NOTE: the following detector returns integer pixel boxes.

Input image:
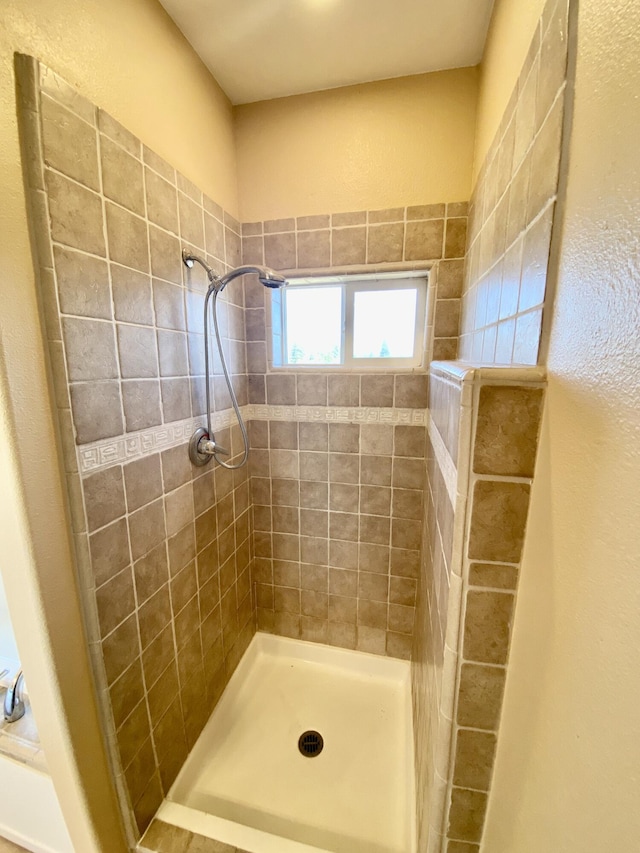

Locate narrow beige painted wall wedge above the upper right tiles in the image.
[473,0,545,185]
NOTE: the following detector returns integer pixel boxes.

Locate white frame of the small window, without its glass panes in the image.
[272,270,429,370]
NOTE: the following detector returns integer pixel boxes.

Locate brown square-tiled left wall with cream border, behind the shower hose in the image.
[17,57,255,836]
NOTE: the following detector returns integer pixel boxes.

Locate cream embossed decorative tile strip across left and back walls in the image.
[76,404,428,476]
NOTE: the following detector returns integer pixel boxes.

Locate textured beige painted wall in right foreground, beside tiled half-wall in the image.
[483,0,640,853]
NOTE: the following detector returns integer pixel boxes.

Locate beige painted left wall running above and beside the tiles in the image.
[0,0,237,853]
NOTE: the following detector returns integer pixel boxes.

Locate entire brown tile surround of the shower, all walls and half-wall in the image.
[12,3,566,853]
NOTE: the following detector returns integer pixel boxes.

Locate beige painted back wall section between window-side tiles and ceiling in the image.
[235,68,477,222]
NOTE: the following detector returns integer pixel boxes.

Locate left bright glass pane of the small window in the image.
[285,286,342,364]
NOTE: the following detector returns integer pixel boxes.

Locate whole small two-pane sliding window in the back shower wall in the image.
[272,272,427,367]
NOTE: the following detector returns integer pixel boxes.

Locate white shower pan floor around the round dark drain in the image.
[156,633,415,853]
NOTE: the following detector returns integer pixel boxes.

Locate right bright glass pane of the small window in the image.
[353,288,418,358]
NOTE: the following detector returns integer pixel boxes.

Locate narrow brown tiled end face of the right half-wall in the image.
[446,380,544,849]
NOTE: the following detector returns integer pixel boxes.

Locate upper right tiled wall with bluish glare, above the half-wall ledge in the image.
[460,0,569,364]
